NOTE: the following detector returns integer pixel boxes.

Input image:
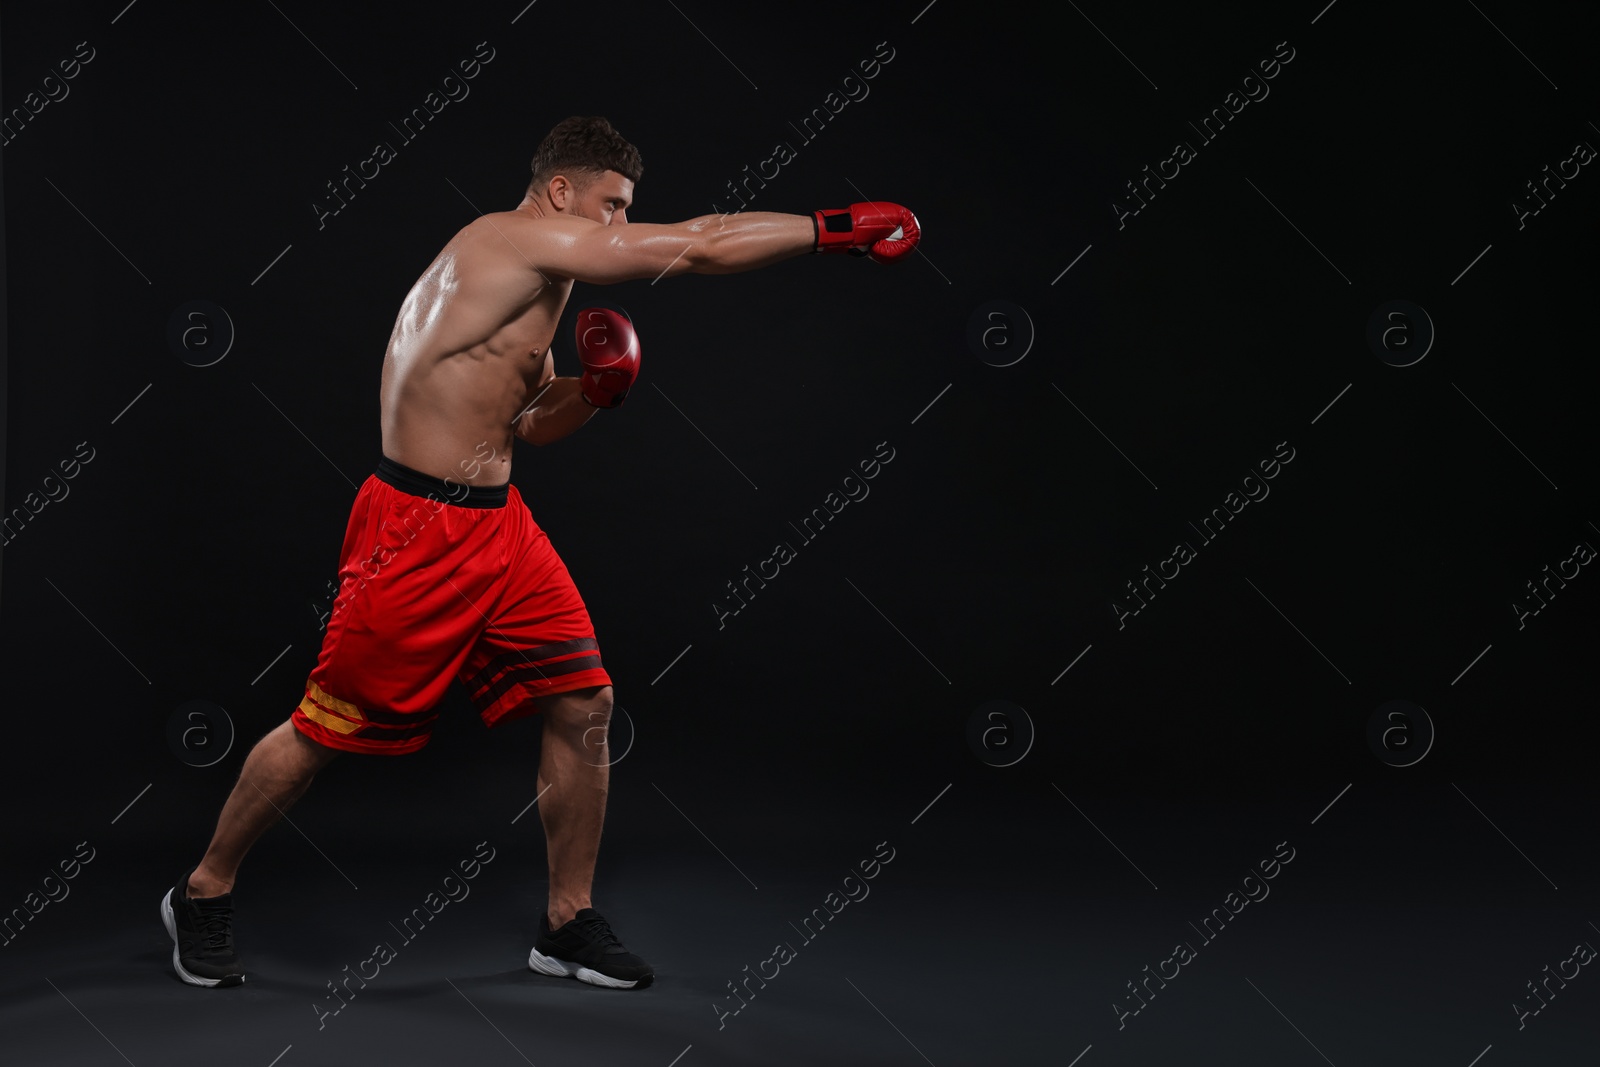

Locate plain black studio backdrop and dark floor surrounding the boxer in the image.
[0,0,1600,1067]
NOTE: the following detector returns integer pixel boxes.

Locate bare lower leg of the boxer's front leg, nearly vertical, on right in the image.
[538,685,611,929]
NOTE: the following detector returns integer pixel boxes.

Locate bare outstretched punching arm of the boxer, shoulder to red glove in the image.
[538,211,816,285]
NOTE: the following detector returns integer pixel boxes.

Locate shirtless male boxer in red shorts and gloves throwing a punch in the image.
[162,117,920,989]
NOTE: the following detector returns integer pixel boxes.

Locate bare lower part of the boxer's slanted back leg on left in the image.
[189,720,339,896]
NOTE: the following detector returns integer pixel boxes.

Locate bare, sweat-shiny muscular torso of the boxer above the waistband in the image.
[379,211,573,486]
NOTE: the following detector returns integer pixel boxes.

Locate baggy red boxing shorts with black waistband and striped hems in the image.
[290,458,611,755]
